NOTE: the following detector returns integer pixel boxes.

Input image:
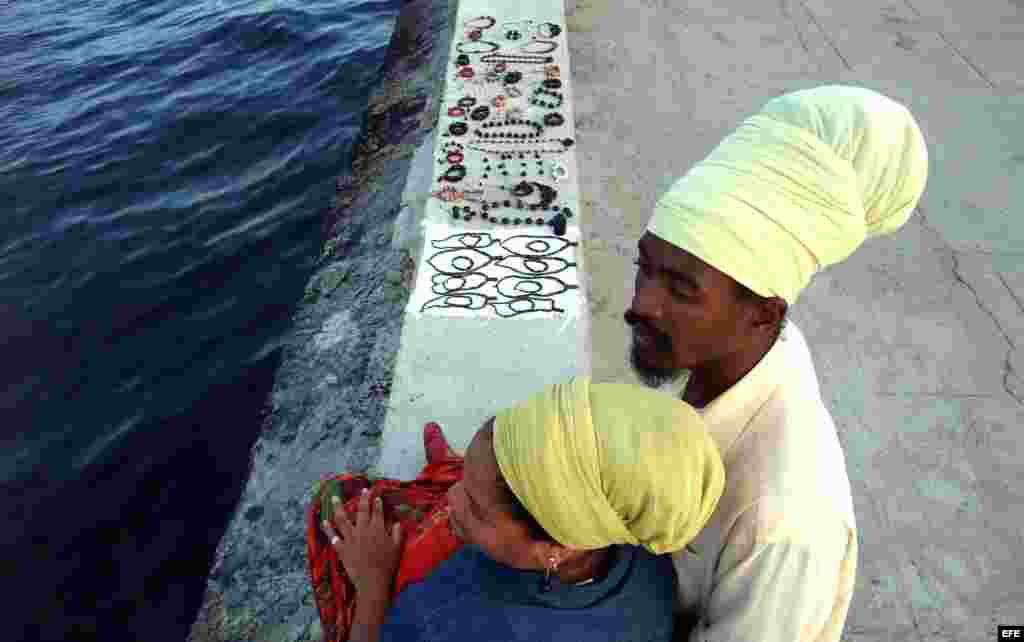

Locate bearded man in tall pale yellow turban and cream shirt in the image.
[626,86,928,642]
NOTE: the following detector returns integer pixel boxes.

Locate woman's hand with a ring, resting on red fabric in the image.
[322,490,401,595]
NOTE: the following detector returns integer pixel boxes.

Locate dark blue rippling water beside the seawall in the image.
[0,0,399,642]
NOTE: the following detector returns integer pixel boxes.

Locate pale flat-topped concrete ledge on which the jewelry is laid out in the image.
[375,0,590,478]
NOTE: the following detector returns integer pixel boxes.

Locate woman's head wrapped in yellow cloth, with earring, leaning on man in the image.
[450,377,724,568]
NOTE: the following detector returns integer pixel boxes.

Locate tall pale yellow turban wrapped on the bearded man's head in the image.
[647,86,928,305]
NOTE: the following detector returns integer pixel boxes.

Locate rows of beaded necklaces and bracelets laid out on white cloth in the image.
[414,11,580,319]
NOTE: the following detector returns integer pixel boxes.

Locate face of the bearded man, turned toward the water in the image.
[625,232,750,387]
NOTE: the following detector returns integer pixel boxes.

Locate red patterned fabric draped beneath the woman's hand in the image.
[306,454,463,642]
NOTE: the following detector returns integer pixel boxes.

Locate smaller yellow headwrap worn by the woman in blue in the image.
[494,377,725,555]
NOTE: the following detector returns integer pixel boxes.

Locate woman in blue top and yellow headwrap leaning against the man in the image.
[309,377,724,642]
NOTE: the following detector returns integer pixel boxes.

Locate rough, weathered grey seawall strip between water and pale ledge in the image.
[189,0,457,642]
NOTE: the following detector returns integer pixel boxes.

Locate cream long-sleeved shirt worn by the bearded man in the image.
[673,320,857,642]
